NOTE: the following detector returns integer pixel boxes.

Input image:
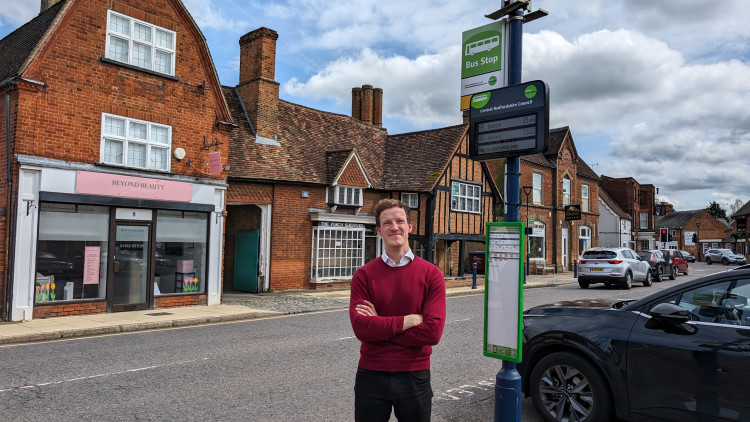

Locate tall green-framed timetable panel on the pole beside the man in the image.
[484,222,525,362]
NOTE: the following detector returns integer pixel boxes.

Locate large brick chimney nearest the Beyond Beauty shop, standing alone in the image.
[237,28,279,143]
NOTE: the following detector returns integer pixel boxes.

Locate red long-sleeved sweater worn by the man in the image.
[349,257,445,372]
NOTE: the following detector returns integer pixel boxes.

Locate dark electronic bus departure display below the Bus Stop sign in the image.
[470,81,549,160]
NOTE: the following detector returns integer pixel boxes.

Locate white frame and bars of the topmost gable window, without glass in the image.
[104,10,177,76]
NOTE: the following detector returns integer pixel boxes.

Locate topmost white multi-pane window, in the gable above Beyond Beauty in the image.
[105,10,177,75]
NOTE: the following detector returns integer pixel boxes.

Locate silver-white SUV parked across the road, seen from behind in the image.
[578,248,653,289]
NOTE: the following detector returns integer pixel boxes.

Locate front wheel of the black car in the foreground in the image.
[530,352,612,422]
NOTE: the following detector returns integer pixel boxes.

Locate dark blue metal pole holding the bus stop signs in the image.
[494,9,523,422]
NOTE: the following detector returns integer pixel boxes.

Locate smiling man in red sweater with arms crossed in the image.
[349,199,445,422]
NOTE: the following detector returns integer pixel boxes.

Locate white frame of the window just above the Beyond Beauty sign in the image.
[99,113,172,172]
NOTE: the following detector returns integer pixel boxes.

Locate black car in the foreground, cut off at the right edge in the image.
[518,268,750,422]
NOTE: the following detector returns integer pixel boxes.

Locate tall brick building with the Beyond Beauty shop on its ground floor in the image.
[0,0,233,321]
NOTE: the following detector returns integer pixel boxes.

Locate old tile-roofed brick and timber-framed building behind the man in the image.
[223,28,499,292]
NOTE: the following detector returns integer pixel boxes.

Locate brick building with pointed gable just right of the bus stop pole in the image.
[490,126,599,272]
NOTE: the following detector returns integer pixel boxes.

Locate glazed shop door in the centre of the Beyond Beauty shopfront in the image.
[108,224,153,312]
